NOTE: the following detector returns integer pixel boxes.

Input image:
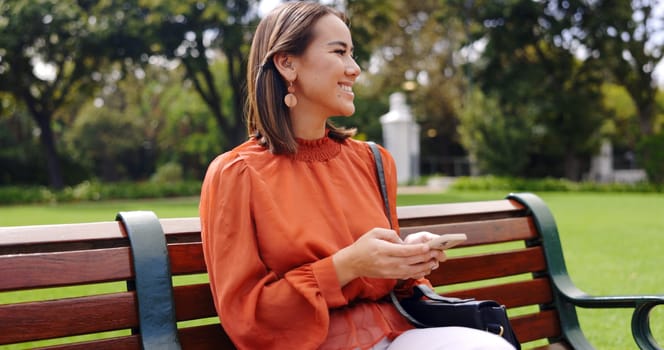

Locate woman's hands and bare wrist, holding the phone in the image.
[332,228,445,286]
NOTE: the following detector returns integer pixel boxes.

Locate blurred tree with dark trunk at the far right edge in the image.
[572,0,664,136]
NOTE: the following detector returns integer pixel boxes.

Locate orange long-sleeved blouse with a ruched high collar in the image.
[200,137,412,349]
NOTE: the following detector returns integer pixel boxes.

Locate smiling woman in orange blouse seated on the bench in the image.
[200,2,511,349]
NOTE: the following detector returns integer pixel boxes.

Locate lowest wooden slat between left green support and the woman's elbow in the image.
[178,324,235,350]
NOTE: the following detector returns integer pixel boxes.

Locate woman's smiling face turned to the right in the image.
[291,14,360,118]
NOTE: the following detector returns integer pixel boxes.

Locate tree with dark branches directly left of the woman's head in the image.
[139,0,258,149]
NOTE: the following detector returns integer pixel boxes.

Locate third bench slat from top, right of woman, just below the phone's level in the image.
[427,247,546,286]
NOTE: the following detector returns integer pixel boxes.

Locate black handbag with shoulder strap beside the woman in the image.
[367,141,521,349]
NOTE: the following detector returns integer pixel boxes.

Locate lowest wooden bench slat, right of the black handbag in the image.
[510,310,560,343]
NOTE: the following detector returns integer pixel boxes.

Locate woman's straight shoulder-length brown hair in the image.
[246,1,355,154]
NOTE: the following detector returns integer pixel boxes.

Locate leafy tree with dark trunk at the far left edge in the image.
[0,0,150,189]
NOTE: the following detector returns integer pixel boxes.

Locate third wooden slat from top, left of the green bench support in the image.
[0,292,138,344]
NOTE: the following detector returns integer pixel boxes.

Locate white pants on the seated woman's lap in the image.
[373,327,514,350]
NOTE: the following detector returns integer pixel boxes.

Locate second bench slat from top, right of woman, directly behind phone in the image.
[401,217,537,247]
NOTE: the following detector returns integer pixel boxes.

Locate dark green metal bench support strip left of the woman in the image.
[115,211,181,350]
